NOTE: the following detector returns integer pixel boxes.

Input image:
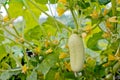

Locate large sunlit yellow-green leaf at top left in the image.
[8,0,47,32]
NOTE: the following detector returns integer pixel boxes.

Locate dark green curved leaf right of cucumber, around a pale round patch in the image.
[87,32,103,51]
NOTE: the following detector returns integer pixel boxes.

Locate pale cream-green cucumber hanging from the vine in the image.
[68,34,85,72]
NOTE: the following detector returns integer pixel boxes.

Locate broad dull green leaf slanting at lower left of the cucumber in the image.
[37,52,58,75]
